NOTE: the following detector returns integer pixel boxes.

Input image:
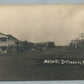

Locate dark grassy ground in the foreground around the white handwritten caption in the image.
[0,48,84,80]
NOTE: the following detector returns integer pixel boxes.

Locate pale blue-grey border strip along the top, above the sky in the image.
[0,0,84,4]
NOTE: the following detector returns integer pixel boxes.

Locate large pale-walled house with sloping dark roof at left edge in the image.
[0,33,19,53]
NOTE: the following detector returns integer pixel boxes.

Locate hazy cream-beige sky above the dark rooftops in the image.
[0,5,84,45]
